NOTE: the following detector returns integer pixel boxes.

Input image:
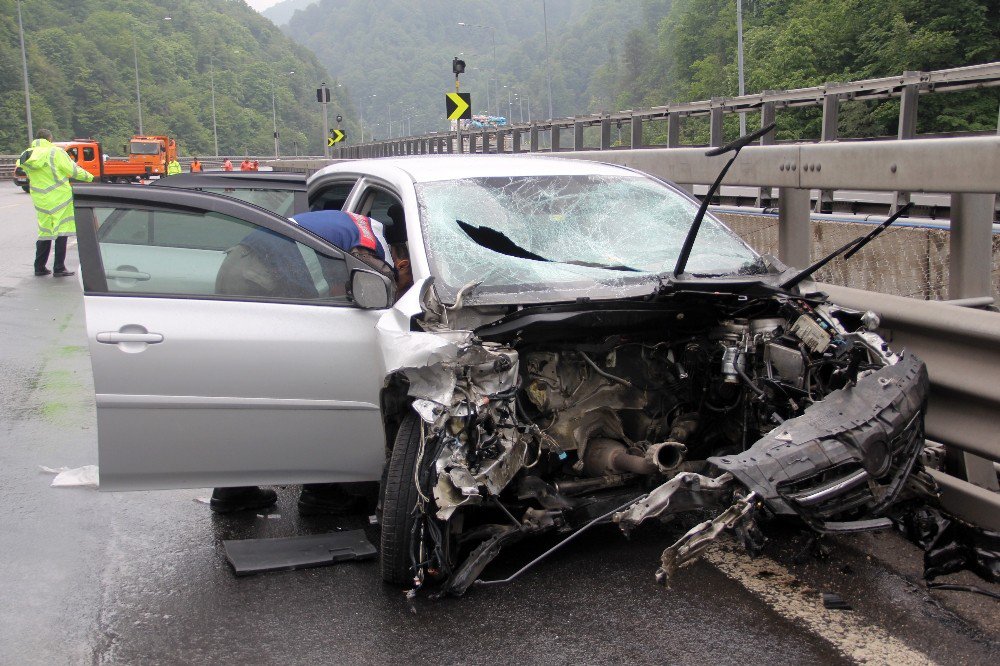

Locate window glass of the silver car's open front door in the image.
[94,208,349,303]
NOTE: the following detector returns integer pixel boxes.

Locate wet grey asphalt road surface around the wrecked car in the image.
[0,183,1000,664]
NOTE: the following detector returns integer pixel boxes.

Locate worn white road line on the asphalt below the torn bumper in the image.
[702,544,935,666]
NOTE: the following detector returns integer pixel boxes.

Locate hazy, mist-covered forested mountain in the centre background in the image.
[280,0,643,138]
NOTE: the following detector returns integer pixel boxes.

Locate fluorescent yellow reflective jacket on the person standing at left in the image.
[21,139,94,240]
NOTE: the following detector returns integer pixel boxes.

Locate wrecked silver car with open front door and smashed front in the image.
[76,155,928,594]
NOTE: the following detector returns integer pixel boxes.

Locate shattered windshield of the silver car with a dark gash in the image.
[416,175,758,301]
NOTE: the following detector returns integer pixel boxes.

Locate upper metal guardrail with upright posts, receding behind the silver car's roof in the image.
[336,62,1000,167]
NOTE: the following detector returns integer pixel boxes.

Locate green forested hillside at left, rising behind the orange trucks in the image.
[0,0,352,155]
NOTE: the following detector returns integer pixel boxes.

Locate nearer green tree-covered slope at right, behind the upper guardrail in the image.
[602,0,1000,139]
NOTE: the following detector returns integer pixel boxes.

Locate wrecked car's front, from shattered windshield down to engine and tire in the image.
[379,165,933,595]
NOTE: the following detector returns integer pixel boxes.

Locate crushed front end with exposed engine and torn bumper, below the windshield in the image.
[386,286,927,594]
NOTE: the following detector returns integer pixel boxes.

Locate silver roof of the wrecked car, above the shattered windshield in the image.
[312,155,636,183]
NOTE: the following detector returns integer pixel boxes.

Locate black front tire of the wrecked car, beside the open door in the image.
[379,411,420,587]
